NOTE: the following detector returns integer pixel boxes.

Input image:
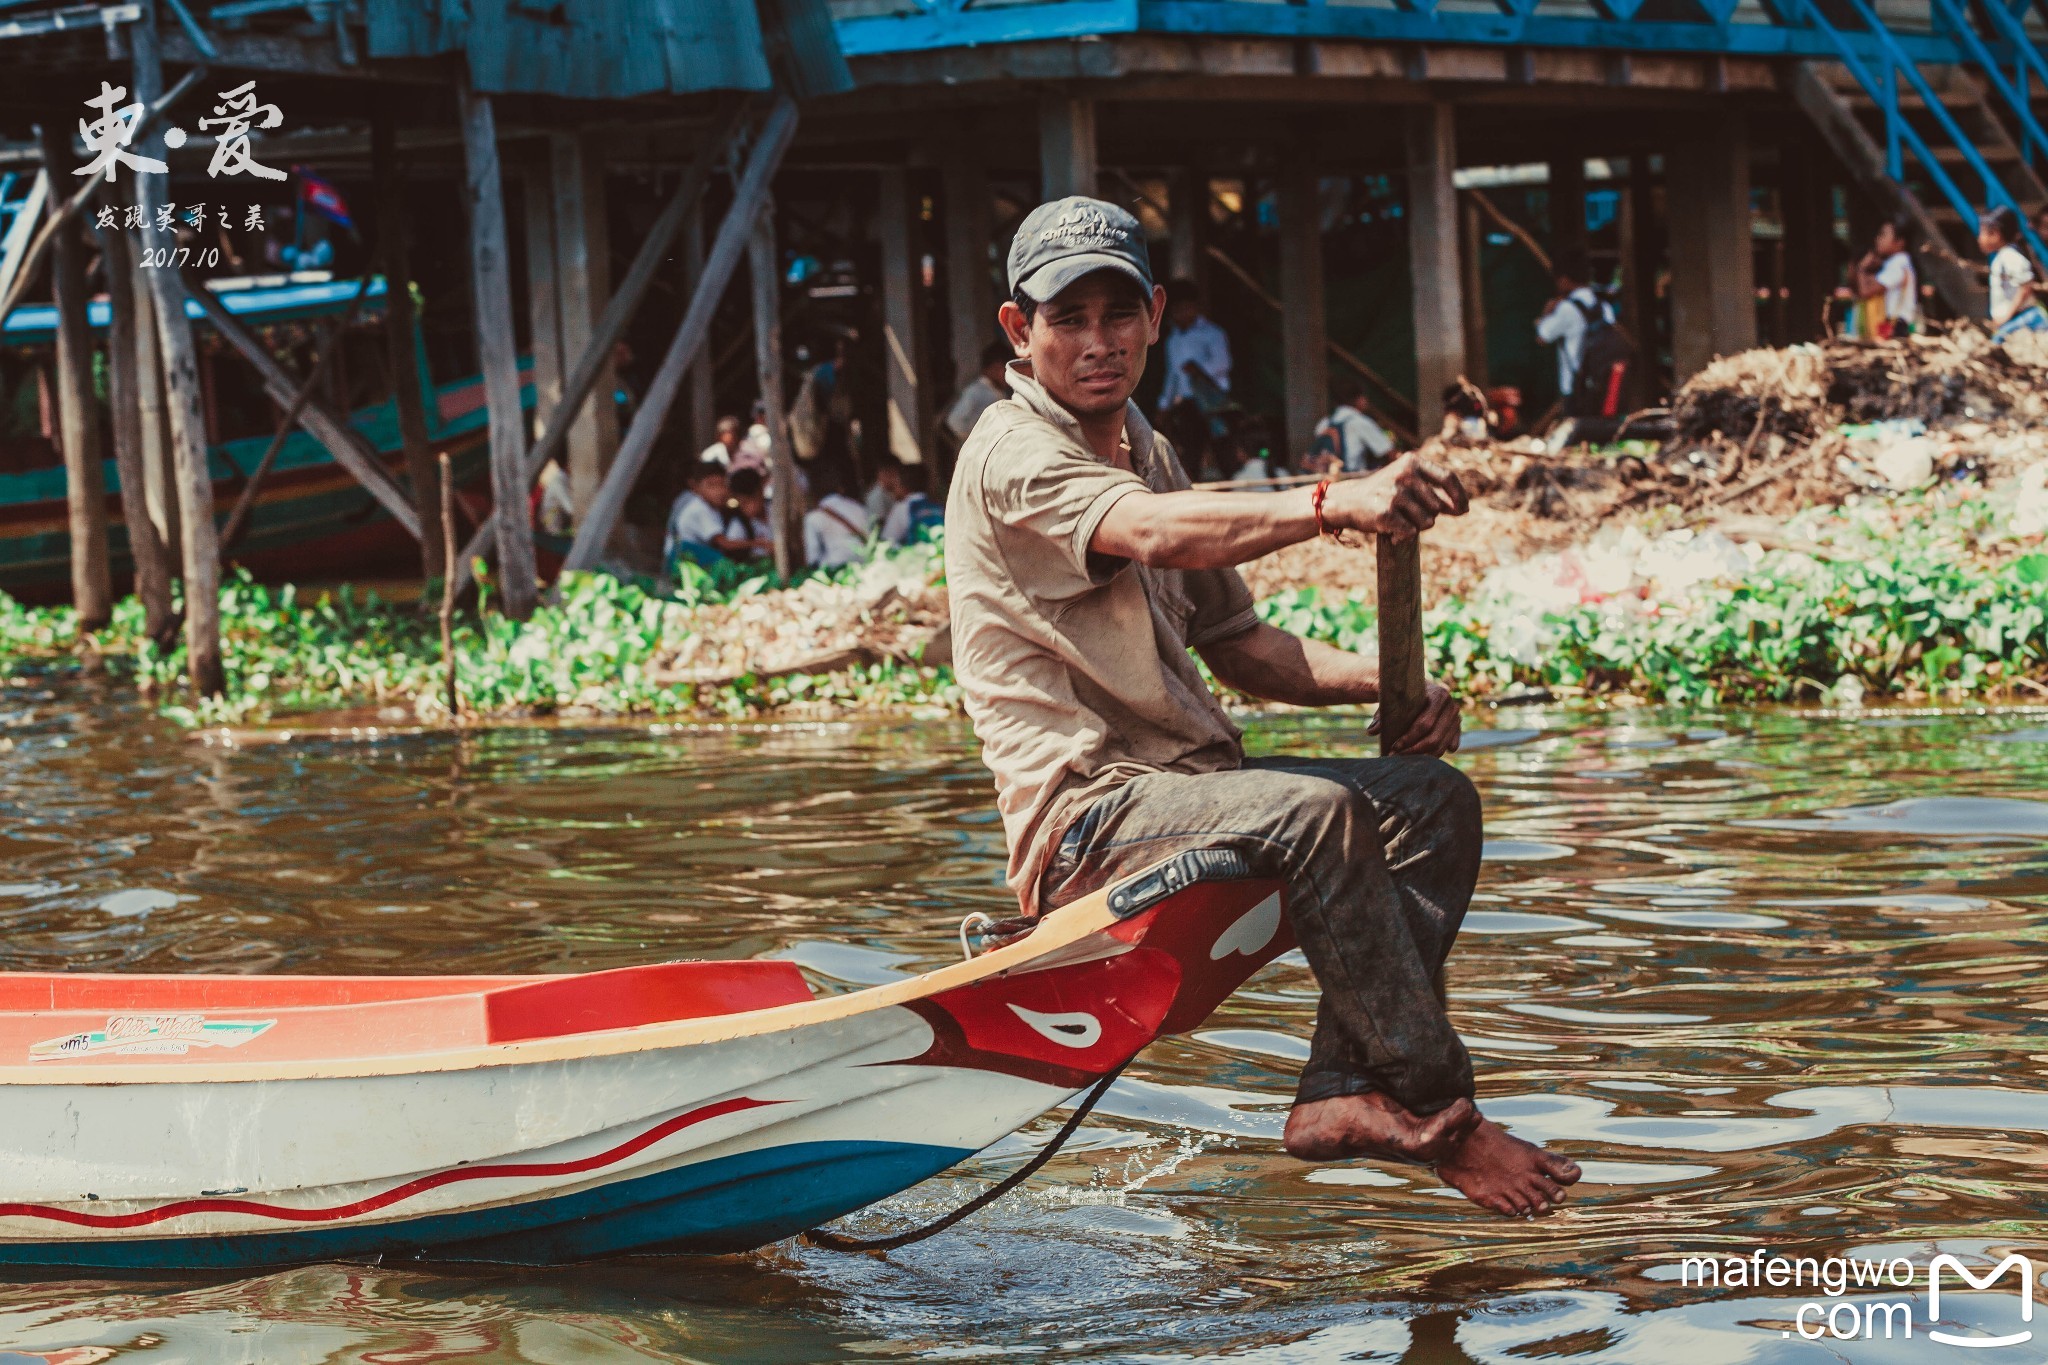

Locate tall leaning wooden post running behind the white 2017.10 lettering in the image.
[127,0,225,696]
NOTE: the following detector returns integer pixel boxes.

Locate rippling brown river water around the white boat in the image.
[0,677,2048,1365]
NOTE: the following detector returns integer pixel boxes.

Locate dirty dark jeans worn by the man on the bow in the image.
[1038,757,1481,1113]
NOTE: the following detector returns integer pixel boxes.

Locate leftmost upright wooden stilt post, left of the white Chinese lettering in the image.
[41,121,115,630]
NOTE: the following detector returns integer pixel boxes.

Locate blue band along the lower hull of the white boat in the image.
[0,1142,971,1269]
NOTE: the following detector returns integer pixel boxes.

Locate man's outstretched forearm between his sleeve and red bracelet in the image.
[1092,487,1315,569]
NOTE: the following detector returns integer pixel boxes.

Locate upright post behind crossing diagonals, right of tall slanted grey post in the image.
[549,133,618,520]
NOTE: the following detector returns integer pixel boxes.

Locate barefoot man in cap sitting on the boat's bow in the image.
[946,196,1579,1216]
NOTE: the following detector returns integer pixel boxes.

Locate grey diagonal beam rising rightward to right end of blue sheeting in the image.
[563,96,797,569]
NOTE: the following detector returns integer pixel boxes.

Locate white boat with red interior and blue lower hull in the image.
[0,851,1292,1269]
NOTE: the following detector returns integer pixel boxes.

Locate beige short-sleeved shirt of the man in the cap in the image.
[946,360,1257,913]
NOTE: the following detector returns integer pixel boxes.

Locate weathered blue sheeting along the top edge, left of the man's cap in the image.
[369,0,852,98]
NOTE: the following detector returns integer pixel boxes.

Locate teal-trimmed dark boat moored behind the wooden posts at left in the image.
[0,276,535,602]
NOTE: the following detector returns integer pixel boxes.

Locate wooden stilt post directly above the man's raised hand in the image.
[1405,104,1466,440]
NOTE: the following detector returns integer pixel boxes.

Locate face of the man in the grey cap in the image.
[1004,270,1165,417]
